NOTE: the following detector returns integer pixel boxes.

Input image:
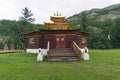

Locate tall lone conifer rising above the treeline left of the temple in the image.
[20,7,35,50]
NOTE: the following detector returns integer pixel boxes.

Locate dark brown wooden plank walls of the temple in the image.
[26,30,87,49]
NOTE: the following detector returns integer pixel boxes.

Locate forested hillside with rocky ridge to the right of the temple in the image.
[65,4,120,49]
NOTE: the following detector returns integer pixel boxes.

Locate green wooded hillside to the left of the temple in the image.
[0,20,44,49]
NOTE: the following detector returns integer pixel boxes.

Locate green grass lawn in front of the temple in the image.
[0,50,120,80]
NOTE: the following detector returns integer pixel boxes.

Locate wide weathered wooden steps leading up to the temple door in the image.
[48,48,80,61]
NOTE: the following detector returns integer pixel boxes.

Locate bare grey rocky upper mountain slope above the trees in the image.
[66,4,120,22]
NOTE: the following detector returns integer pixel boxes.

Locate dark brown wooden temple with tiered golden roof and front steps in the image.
[25,12,88,61]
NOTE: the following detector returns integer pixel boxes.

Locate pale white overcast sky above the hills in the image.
[0,0,120,24]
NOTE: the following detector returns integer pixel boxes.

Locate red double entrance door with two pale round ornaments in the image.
[56,36,65,48]
